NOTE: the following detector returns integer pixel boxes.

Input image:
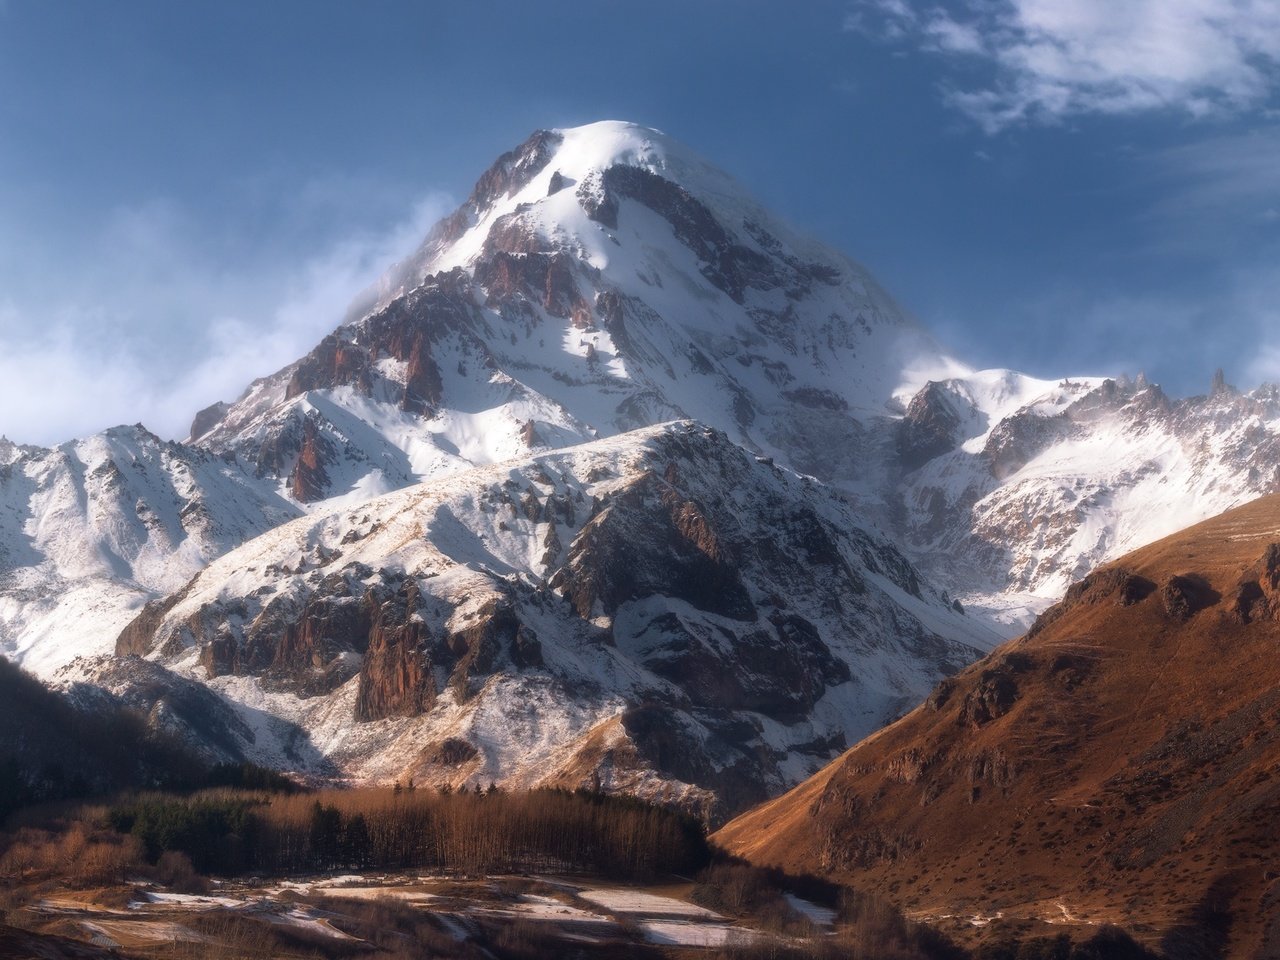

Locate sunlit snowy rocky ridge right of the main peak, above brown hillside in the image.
[897,371,1280,634]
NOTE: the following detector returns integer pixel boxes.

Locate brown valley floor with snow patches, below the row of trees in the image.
[0,873,835,960]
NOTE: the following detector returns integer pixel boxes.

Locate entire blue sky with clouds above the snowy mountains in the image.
[0,0,1280,443]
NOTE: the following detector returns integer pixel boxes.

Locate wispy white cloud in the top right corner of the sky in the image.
[845,0,1280,133]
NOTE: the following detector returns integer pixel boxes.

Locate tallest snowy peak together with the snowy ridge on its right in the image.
[192,123,1280,634]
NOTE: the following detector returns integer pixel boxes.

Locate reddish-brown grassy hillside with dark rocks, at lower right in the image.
[714,497,1280,957]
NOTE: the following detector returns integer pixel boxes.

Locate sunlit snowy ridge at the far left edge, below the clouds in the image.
[0,426,300,675]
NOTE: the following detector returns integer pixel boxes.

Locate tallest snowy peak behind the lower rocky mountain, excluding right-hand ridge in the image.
[186,120,955,519]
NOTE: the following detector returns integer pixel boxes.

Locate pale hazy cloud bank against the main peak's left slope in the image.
[0,183,448,444]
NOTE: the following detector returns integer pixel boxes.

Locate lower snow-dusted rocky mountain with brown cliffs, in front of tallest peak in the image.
[88,422,992,810]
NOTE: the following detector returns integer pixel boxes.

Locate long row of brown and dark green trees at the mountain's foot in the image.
[108,790,710,878]
